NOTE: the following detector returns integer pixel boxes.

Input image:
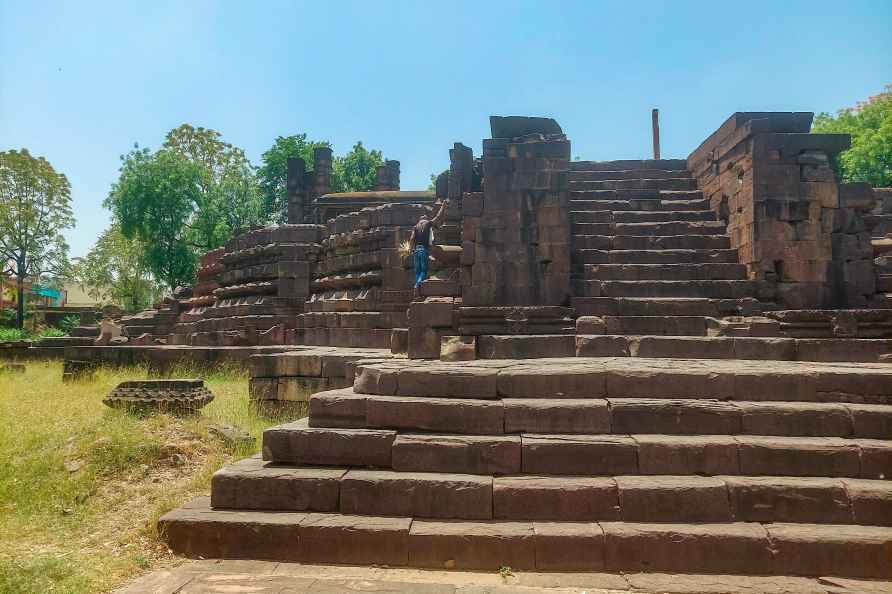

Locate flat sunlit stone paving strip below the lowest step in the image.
[117,559,892,594]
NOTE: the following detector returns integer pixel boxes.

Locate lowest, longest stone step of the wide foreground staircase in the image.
[159,498,892,578]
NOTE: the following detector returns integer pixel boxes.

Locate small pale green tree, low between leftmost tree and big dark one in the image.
[73,224,161,312]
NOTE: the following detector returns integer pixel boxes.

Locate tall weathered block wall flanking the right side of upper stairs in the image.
[688,112,875,308]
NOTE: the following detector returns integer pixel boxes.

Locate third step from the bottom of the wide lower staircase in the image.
[263,420,892,479]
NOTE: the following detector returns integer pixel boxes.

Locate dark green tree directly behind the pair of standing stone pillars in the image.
[257,134,330,223]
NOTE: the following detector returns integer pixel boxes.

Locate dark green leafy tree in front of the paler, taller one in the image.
[105,147,199,289]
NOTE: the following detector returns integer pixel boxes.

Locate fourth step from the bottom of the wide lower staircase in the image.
[308,389,892,439]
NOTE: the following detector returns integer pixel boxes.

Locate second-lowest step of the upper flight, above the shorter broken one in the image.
[572,297,759,317]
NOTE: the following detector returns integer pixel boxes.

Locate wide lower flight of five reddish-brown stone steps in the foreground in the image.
[161,357,892,578]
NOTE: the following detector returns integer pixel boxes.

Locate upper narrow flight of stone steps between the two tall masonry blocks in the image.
[569,159,758,336]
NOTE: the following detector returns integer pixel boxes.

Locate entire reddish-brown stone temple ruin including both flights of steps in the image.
[69,113,892,578]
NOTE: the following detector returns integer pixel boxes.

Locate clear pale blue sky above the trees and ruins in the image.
[0,0,892,256]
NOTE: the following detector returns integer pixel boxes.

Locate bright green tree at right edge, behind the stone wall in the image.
[812,85,892,187]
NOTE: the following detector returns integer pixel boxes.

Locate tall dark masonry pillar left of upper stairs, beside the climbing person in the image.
[460,116,570,306]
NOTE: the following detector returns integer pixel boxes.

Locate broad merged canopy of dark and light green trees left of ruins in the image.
[105,124,266,289]
